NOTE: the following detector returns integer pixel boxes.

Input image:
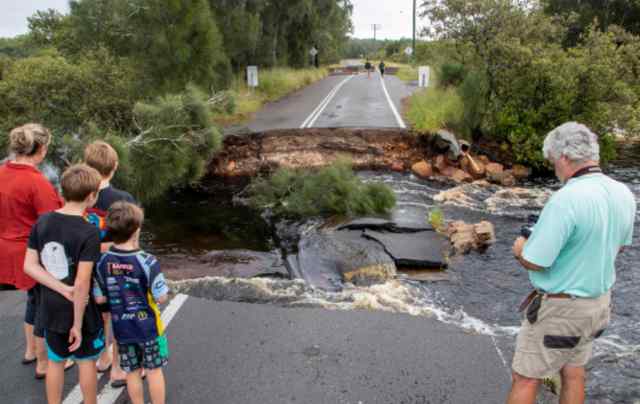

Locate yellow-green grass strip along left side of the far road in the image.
[214,67,329,126]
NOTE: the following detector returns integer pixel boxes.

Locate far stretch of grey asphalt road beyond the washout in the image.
[248,73,416,131]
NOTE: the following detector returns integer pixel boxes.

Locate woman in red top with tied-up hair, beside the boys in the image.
[0,124,62,378]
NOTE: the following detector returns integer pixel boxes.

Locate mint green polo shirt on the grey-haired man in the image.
[522,173,636,297]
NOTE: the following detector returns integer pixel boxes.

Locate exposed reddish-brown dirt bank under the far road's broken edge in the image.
[208,128,431,178]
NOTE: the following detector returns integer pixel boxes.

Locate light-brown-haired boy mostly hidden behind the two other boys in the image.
[84,141,135,387]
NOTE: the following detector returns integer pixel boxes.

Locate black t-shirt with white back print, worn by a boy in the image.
[29,212,102,334]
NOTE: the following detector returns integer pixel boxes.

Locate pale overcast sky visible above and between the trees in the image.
[0,0,420,39]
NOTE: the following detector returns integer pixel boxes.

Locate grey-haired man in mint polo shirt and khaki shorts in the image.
[507,122,636,404]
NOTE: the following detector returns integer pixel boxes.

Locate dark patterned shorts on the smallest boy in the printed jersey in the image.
[118,335,169,373]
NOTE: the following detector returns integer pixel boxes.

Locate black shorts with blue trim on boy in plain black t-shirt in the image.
[44,330,104,362]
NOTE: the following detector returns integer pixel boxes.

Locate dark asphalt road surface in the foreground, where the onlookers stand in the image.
[0,292,509,404]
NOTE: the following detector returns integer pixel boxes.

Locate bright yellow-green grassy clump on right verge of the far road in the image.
[407,87,464,132]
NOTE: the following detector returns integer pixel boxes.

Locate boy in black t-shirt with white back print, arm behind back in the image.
[24,164,104,404]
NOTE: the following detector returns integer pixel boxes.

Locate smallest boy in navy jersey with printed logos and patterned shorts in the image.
[94,202,169,404]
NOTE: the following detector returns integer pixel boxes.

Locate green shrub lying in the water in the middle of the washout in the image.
[249,160,396,217]
